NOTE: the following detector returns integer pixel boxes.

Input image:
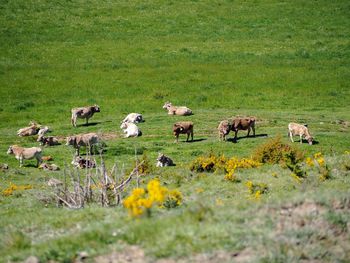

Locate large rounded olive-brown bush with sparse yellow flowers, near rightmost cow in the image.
[253,136,304,165]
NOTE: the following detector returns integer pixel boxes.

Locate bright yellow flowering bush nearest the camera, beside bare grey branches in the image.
[123,179,182,217]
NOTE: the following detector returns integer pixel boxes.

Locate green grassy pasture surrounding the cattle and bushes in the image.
[0,0,350,262]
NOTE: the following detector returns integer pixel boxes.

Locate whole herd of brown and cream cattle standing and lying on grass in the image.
[7,102,313,170]
